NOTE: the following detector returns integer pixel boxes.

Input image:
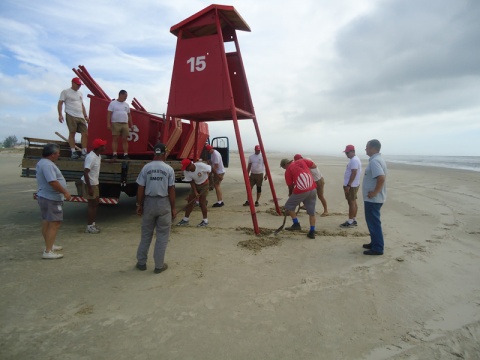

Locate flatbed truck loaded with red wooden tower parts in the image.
[21,66,229,204]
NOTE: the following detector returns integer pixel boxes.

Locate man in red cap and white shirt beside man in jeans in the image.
[340,145,362,228]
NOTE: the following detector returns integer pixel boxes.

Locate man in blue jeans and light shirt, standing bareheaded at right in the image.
[362,139,387,255]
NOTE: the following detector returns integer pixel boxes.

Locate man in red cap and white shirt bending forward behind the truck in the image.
[177,159,212,227]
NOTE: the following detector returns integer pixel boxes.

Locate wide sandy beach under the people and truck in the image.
[0,151,480,360]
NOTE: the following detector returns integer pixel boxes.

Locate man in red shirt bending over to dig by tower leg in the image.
[280,159,317,239]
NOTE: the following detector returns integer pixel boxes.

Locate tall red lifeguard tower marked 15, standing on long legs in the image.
[167,5,280,234]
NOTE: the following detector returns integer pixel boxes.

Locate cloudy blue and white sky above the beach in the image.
[0,0,480,156]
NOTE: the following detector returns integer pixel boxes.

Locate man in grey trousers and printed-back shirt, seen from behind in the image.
[136,143,177,274]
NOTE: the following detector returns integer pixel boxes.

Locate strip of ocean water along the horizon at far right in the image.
[383,155,480,172]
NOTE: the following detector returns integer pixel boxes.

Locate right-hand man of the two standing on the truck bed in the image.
[107,90,133,159]
